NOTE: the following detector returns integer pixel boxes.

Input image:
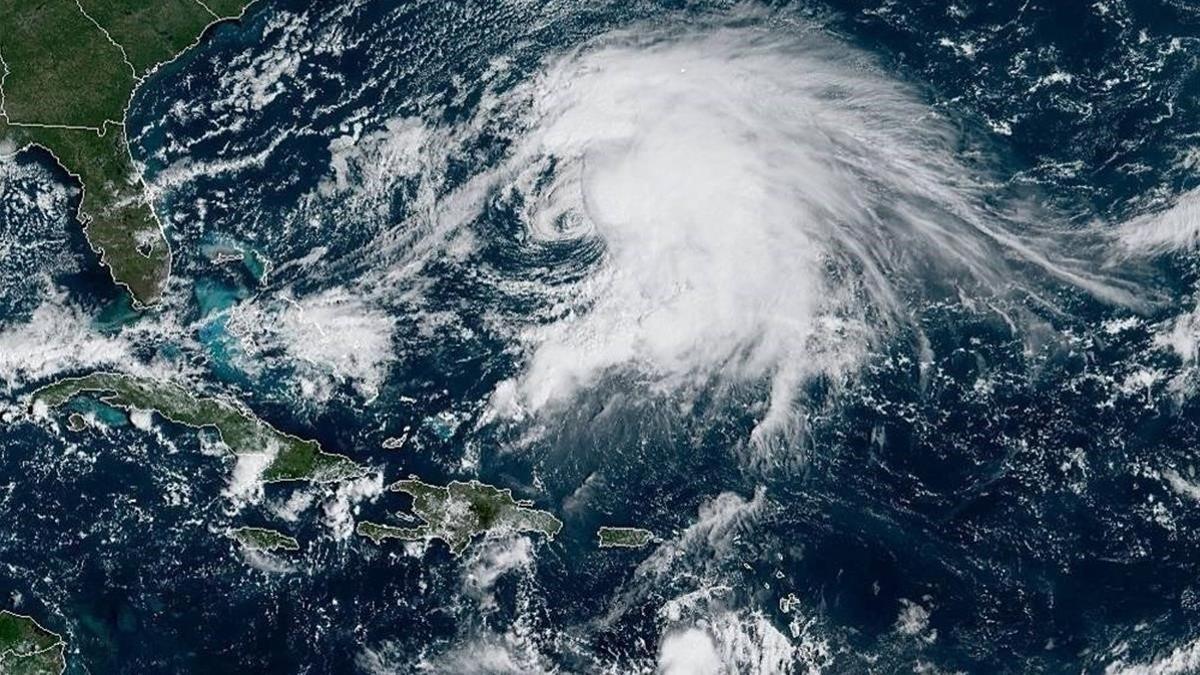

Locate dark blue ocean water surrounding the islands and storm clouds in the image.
[7,0,1200,673]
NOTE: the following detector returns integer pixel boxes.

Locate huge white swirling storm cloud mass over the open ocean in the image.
[355,26,1140,436]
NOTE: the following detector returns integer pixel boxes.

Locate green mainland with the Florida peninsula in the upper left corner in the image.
[0,0,252,305]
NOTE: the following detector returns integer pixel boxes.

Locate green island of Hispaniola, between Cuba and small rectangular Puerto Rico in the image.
[356,478,563,557]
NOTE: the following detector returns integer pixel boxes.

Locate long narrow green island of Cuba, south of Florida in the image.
[32,372,362,483]
